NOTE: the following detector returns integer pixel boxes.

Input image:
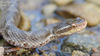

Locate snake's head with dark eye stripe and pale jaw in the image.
[53,17,87,36]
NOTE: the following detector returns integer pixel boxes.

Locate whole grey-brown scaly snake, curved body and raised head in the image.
[0,0,87,48]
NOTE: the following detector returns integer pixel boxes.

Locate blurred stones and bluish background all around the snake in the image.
[0,0,100,56]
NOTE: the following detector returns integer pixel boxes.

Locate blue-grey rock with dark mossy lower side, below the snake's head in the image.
[61,34,99,53]
